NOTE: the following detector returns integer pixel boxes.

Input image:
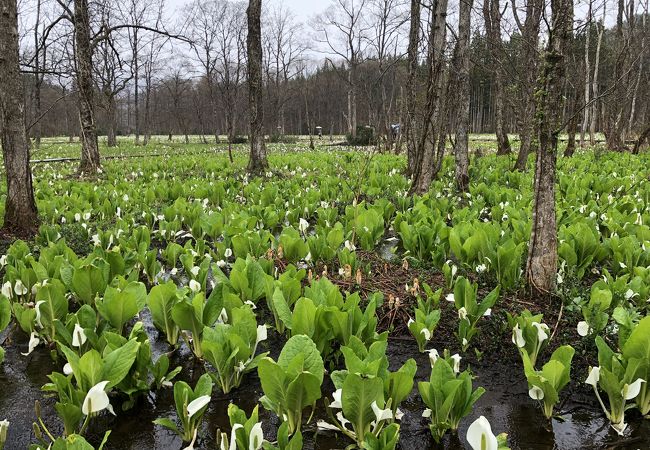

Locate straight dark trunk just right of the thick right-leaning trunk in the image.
[454,0,473,192]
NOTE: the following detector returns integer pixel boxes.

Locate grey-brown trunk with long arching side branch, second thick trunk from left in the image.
[74,0,101,175]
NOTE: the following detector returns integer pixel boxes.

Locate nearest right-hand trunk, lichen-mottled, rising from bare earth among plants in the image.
[526,0,573,295]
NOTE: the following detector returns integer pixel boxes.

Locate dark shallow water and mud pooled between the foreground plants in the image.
[0,317,650,450]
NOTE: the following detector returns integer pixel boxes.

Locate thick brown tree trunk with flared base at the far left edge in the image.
[0,0,38,237]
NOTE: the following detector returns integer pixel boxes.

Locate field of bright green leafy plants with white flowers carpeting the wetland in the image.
[0,142,650,449]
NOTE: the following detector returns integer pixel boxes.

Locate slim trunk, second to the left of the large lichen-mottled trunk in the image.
[483,0,511,155]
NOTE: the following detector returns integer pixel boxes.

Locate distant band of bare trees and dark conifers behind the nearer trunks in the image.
[15,0,650,149]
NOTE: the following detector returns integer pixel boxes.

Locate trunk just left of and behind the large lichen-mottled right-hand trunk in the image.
[512,0,545,170]
